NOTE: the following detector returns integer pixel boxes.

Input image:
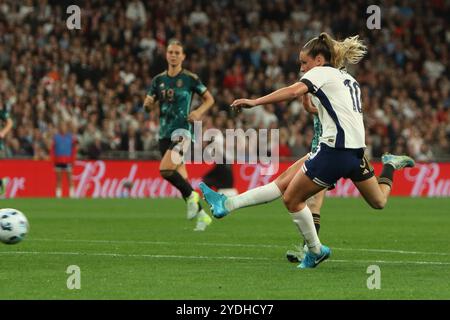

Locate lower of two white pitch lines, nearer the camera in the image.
[0,251,450,266]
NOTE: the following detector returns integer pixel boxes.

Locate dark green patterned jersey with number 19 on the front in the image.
[148,69,207,139]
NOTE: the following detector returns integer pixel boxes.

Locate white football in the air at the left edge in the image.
[0,208,30,244]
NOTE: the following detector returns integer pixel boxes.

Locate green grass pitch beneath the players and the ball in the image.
[0,198,450,300]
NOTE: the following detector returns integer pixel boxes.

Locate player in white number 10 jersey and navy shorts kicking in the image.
[202,33,414,269]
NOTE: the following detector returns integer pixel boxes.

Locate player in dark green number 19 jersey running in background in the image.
[144,40,214,231]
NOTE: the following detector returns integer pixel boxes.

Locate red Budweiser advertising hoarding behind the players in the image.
[0,160,450,198]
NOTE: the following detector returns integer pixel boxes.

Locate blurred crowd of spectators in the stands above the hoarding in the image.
[0,0,450,161]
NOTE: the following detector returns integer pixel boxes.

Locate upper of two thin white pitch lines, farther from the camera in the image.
[30,238,450,256]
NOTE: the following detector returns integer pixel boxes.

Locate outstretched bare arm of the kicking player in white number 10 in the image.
[231,82,308,108]
